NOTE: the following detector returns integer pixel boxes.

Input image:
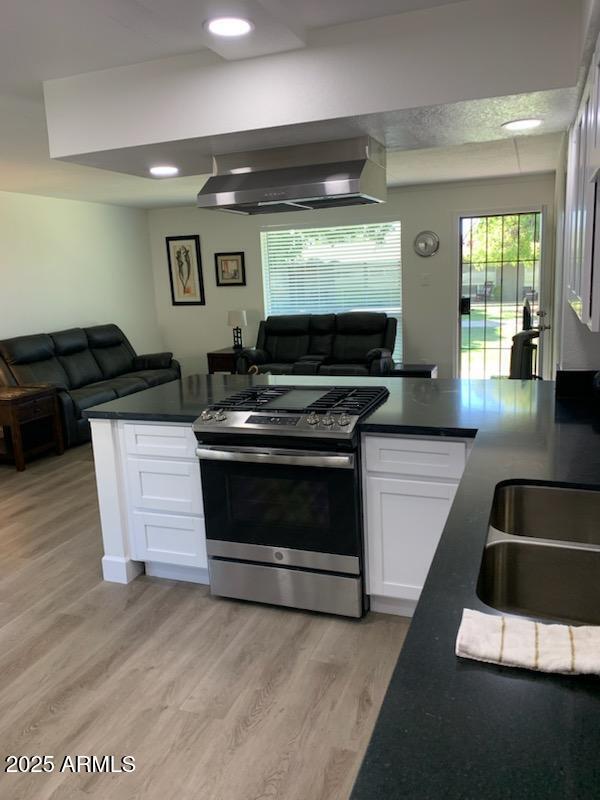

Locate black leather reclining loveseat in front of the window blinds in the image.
[236,311,397,376]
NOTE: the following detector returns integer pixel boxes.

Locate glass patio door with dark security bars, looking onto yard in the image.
[460,211,542,378]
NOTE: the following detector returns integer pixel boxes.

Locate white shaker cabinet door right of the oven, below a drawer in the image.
[366,475,458,600]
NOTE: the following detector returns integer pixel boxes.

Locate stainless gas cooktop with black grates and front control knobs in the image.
[194,386,389,438]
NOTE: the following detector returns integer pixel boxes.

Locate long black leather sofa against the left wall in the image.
[0,325,181,447]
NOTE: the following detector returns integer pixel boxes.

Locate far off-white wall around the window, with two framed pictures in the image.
[148,175,554,377]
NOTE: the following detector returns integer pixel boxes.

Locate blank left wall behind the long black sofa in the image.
[0,192,162,352]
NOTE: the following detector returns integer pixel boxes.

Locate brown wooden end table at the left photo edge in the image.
[0,386,65,472]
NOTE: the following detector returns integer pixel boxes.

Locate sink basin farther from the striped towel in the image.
[490,483,600,546]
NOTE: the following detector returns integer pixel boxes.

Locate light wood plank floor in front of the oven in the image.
[0,447,407,800]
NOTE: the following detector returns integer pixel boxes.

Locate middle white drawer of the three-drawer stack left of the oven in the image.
[127,458,203,516]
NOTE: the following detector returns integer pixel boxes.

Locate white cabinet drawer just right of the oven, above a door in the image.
[365,436,467,480]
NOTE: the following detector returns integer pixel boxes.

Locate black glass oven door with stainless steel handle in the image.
[197,445,361,575]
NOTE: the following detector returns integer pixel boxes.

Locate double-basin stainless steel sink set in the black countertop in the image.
[477,484,600,624]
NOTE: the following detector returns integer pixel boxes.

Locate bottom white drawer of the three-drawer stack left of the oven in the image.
[133,511,208,567]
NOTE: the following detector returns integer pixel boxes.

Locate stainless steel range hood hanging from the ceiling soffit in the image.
[198,136,387,214]
